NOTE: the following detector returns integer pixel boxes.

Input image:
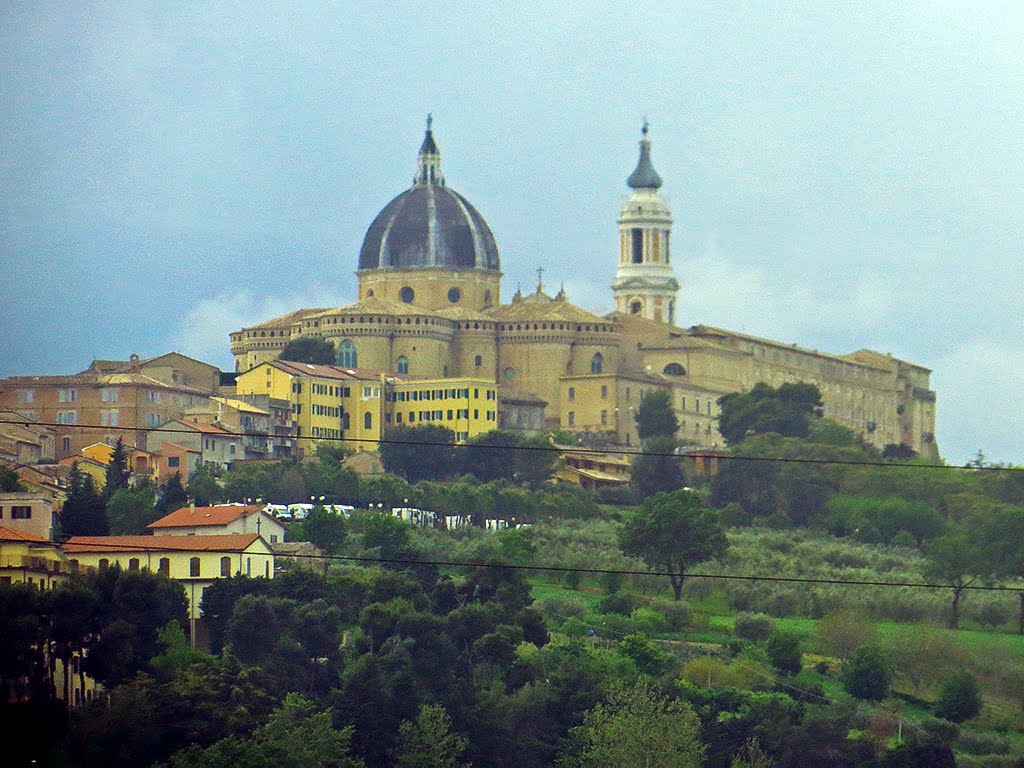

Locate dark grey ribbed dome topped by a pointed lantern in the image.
[359,123,501,271]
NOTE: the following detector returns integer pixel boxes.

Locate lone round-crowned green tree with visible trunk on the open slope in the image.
[620,490,728,600]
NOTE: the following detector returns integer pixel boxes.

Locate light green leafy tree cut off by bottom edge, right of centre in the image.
[558,681,705,768]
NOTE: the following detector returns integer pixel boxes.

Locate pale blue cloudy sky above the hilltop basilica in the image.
[0,0,1024,463]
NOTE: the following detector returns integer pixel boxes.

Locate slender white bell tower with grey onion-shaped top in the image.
[611,120,679,325]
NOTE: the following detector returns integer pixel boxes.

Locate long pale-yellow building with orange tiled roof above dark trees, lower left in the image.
[65,534,273,620]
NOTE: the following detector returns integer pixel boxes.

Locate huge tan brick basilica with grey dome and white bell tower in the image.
[230,119,938,459]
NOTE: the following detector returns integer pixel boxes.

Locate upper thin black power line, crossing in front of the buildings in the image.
[9,421,1024,472]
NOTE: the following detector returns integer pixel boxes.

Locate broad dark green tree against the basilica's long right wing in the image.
[718,382,823,445]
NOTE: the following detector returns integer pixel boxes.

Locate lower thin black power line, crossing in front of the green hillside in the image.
[59,537,1024,592]
